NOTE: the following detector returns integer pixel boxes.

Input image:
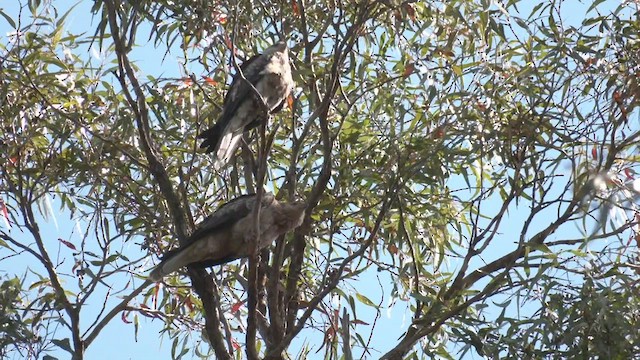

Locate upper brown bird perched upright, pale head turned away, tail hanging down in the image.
[198,41,294,169]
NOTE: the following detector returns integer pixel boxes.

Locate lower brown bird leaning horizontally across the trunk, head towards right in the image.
[149,193,306,281]
